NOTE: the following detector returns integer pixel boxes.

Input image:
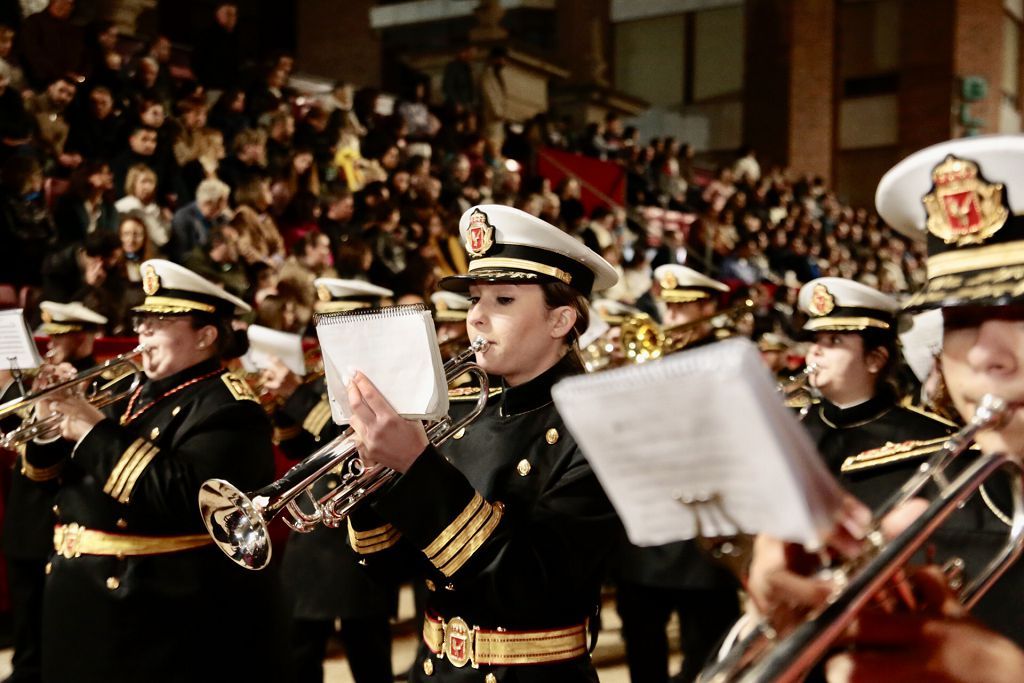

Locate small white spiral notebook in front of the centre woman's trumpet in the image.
[316,305,449,424]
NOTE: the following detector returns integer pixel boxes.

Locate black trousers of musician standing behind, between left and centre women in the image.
[292,616,393,683]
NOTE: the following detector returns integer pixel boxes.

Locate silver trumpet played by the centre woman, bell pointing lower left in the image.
[199,337,488,569]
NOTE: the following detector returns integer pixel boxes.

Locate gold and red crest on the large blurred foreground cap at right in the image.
[924,155,1010,246]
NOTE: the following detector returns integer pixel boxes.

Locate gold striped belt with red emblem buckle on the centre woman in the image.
[423,616,588,667]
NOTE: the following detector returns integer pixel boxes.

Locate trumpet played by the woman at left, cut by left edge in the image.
[0,344,145,450]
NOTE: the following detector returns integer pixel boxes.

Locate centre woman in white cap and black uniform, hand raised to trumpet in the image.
[348,206,621,682]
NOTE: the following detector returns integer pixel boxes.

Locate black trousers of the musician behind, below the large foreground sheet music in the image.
[616,583,739,683]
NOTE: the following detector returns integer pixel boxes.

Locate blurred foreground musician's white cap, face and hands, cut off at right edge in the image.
[752,136,1024,683]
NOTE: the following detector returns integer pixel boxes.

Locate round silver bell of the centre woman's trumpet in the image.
[199,479,271,569]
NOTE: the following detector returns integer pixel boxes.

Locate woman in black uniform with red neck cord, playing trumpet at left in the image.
[25,260,287,682]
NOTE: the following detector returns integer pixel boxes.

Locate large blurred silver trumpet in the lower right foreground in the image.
[699,395,1024,683]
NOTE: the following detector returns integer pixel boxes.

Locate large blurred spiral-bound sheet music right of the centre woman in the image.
[552,339,842,548]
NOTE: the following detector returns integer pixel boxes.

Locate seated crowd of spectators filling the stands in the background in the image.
[0,0,924,342]
